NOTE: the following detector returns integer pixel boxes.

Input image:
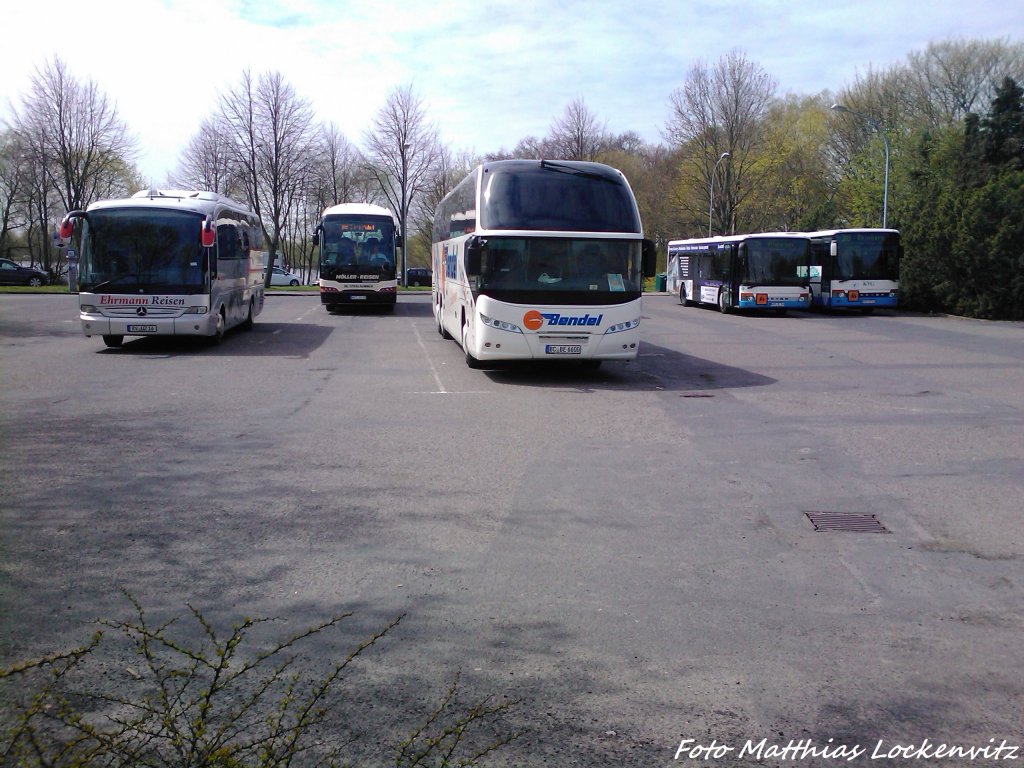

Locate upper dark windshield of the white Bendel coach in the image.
[480,163,640,232]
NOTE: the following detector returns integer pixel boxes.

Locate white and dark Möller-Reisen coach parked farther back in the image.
[313,203,401,312]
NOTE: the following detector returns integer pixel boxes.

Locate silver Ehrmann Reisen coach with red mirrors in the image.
[59,189,266,347]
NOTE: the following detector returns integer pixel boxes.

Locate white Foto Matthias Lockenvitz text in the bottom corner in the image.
[675,738,1020,761]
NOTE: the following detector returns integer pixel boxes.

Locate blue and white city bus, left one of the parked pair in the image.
[666,232,811,312]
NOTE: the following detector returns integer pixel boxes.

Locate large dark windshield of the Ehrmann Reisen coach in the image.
[78,208,206,294]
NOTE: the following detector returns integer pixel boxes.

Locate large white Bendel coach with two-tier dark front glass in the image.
[431,160,654,368]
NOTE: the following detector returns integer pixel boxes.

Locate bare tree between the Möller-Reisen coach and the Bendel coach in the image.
[364,85,441,285]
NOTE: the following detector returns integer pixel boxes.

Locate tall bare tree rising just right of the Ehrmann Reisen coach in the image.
[220,71,315,286]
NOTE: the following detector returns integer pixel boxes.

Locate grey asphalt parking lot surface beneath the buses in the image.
[0,294,1024,766]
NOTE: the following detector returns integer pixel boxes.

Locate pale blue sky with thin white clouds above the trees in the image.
[0,0,1024,185]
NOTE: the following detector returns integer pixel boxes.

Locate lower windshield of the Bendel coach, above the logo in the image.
[476,237,643,304]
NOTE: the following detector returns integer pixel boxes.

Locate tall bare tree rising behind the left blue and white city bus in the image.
[666,51,776,231]
